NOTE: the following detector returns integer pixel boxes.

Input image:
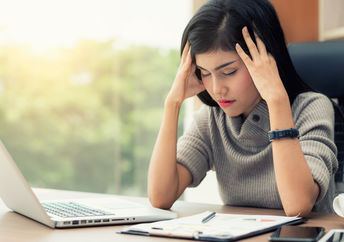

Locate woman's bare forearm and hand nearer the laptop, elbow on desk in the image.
[148,43,196,209]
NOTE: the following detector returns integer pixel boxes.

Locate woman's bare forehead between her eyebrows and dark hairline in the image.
[195,50,240,69]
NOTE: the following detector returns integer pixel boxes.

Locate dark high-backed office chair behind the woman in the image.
[288,40,344,193]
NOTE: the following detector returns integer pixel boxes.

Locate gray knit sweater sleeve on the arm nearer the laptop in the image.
[177,106,212,187]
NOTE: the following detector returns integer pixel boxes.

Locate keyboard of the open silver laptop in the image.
[42,202,114,218]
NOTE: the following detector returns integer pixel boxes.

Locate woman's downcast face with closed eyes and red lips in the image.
[195,50,261,117]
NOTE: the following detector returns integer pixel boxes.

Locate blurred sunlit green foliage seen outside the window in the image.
[0,40,182,195]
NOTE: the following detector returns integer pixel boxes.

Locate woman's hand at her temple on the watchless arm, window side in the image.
[167,42,205,105]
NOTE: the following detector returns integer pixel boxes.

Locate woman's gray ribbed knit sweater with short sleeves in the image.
[177,92,338,212]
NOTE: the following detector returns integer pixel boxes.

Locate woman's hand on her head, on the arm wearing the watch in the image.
[235,27,287,102]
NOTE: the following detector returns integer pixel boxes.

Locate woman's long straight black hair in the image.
[181,0,312,106]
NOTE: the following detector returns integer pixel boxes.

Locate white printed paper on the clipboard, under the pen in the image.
[122,212,299,238]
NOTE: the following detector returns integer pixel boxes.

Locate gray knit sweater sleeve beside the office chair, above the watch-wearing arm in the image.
[292,92,338,202]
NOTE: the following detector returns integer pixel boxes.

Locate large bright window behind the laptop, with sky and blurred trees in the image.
[0,0,192,195]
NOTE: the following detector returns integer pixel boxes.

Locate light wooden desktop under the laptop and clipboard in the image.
[0,189,344,242]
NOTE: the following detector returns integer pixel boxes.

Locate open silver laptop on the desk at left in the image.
[0,141,177,228]
